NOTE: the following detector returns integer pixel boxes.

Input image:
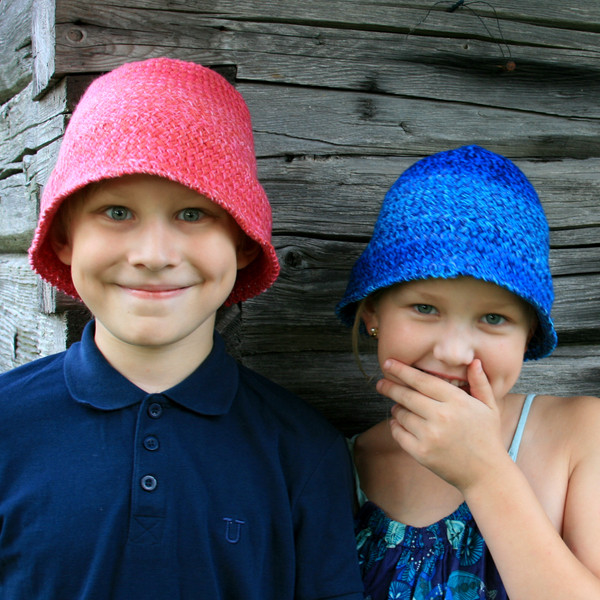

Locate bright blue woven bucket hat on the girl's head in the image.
[336,146,557,360]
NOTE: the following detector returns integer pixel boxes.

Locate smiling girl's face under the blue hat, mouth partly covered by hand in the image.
[362,277,536,399]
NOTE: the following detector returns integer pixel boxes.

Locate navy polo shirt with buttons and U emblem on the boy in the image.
[0,323,363,600]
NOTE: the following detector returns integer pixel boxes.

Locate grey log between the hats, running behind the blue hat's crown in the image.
[258,155,600,237]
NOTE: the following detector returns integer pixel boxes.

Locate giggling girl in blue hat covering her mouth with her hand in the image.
[337,146,600,600]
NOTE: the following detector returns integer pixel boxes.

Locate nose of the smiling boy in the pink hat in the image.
[129,220,179,271]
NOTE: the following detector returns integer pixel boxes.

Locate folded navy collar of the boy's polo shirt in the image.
[65,321,239,416]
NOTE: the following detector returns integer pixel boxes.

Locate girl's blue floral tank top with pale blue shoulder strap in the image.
[356,394,535,600]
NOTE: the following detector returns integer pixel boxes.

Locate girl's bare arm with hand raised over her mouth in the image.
[378,360,600,600]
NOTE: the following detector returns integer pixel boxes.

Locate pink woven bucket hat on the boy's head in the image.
[29,58,279,305]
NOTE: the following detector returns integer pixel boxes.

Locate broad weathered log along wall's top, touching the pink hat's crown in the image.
[30,0,600,117]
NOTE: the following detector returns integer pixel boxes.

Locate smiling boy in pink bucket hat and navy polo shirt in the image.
[0,59,362,600]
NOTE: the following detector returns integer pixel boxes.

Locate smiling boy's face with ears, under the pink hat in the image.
[53,175,257,356]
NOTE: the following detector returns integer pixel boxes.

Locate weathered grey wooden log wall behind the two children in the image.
[0,0,600,433]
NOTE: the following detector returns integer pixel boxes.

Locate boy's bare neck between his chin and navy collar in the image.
[94,321,214,393]
